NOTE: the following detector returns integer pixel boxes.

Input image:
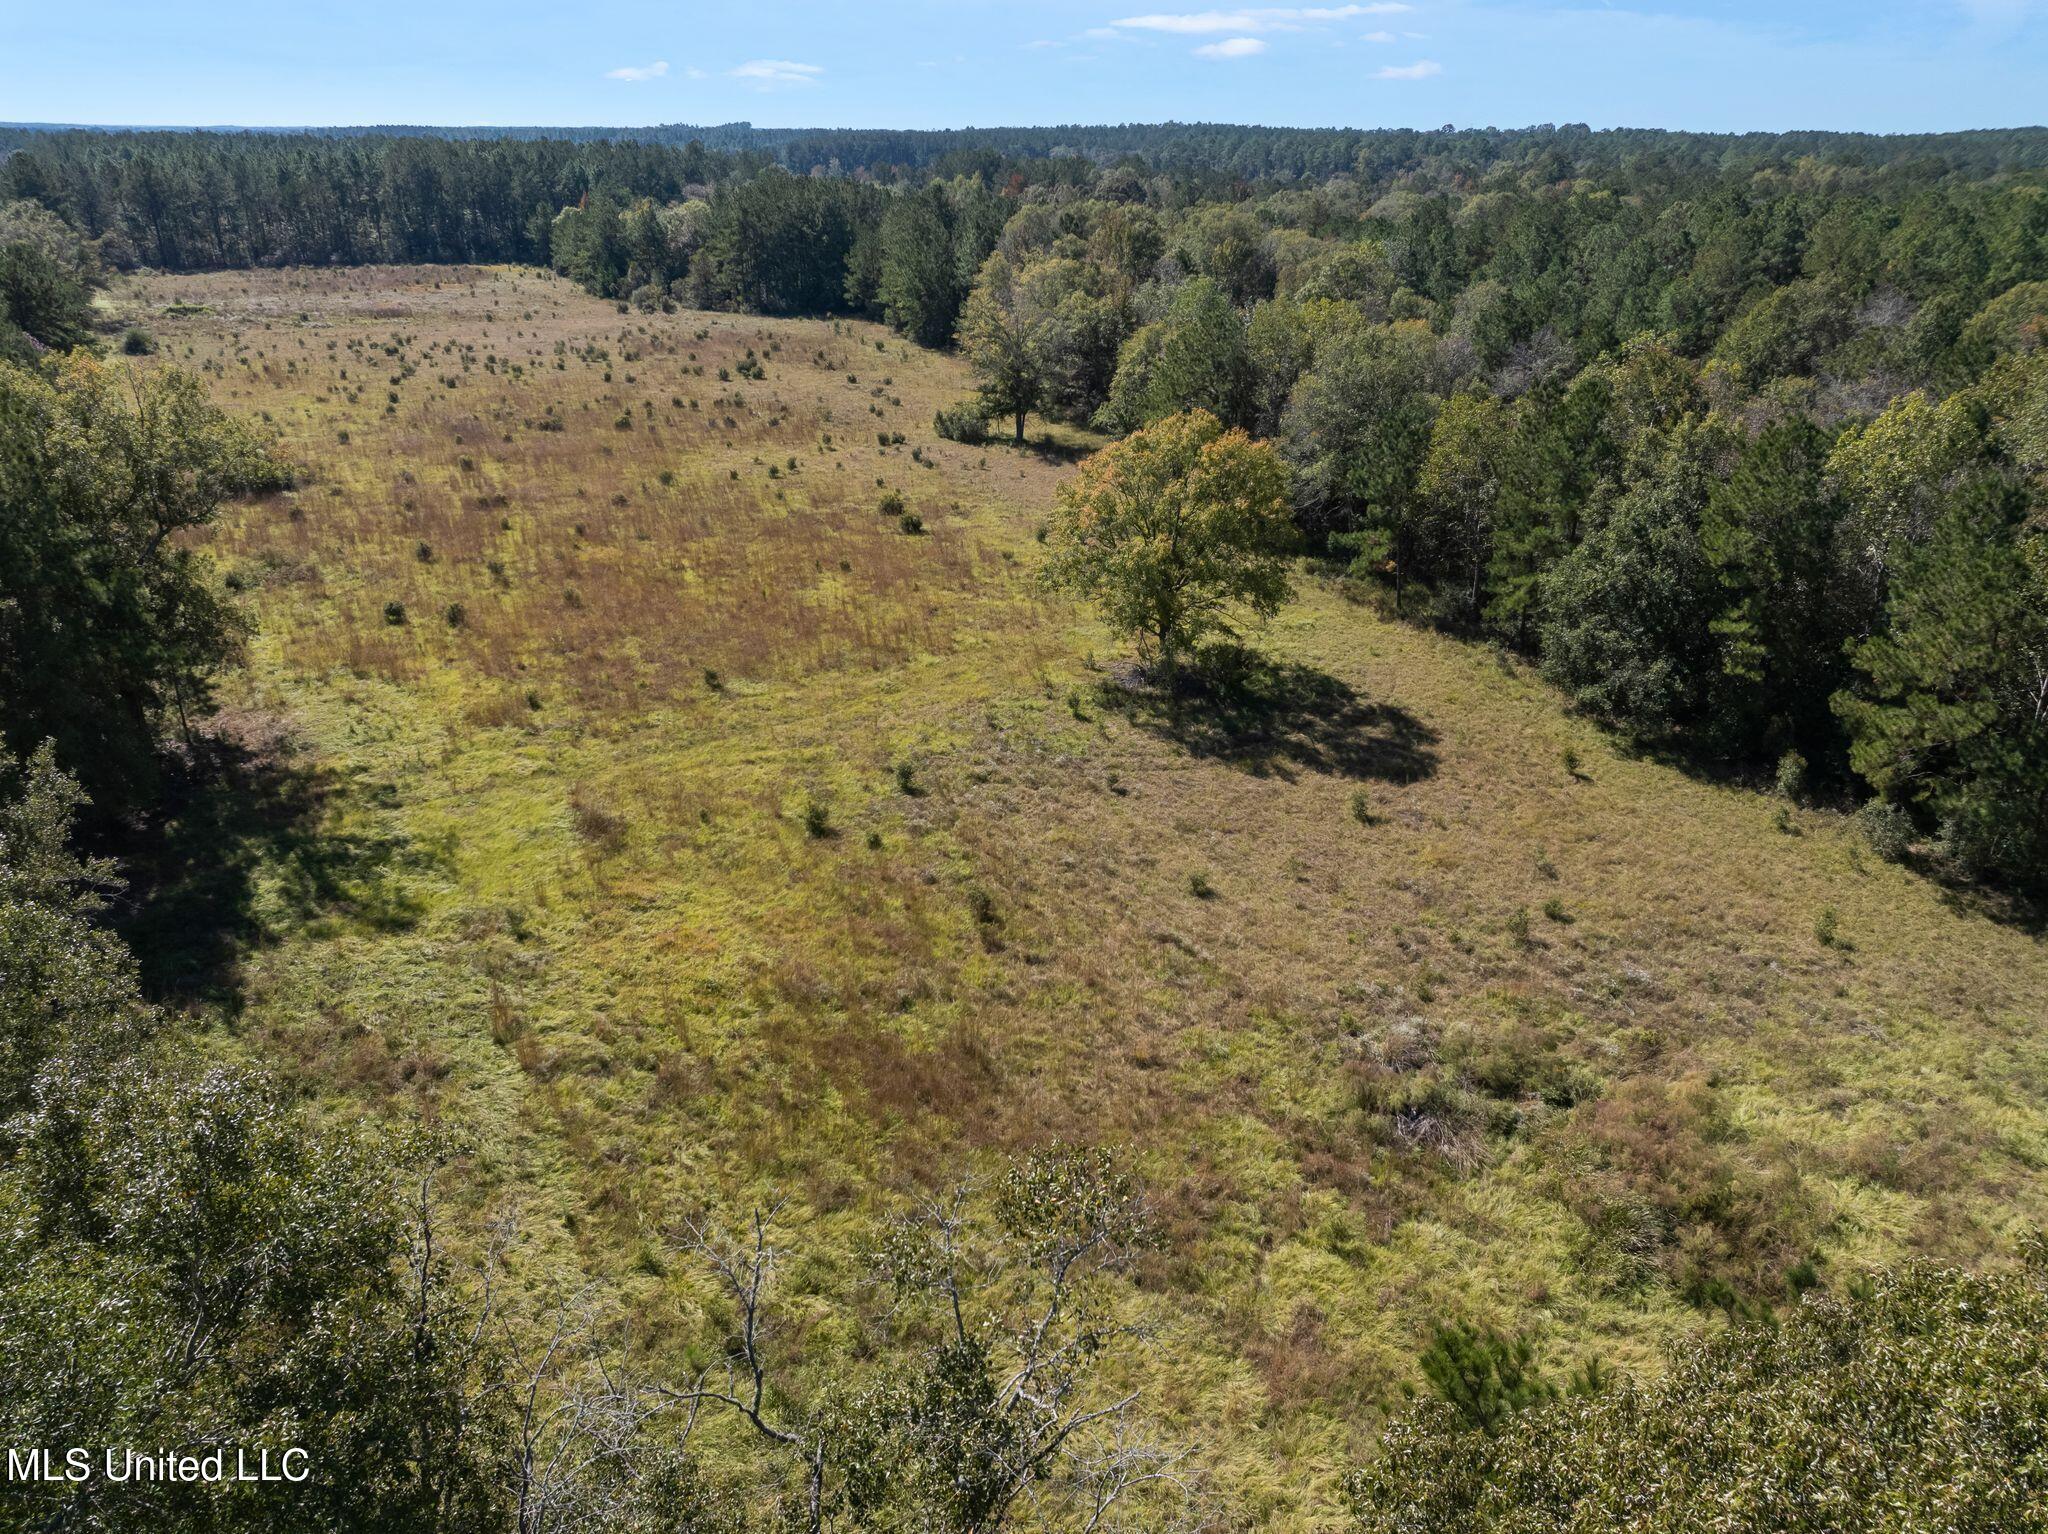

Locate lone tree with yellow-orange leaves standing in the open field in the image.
[1044,410,1294,676]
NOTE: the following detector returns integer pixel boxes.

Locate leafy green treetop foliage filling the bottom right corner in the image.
[1350,1245,2048,1534]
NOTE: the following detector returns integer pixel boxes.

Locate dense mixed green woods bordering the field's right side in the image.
[940,174,2048,883]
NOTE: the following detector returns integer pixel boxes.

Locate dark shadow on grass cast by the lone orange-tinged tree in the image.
[1102,645,1438,782]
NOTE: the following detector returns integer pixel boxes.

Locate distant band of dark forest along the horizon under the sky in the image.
[12,123,2048,284]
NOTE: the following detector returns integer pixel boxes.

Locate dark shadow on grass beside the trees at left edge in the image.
[106,717,442,1012]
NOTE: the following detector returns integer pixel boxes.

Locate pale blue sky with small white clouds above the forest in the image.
[12,0,2048,131]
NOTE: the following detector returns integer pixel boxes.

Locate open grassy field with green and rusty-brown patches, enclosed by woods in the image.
[117,268,2048,1530]
